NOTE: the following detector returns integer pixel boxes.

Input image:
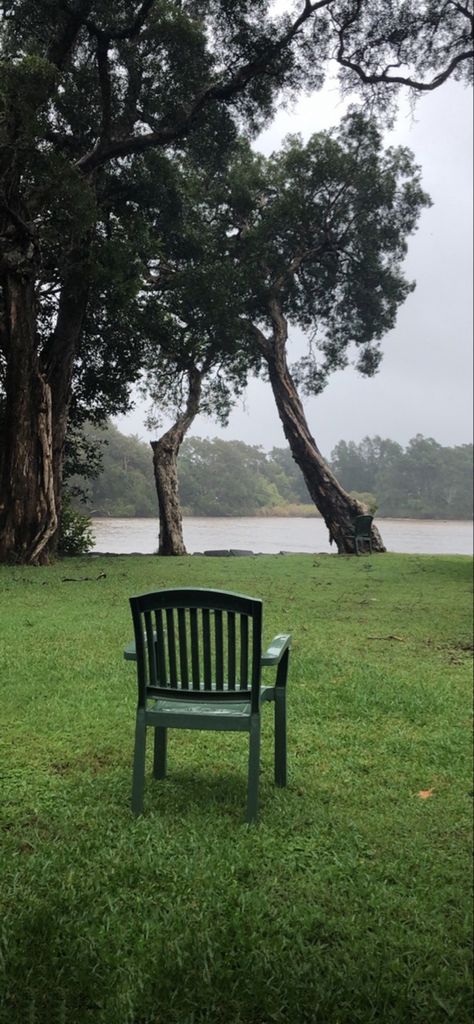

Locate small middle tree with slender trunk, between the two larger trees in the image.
[139,154,260,555]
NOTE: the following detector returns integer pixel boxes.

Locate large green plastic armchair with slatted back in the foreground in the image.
[124,588,291,822]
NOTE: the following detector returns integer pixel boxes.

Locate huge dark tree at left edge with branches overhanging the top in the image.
[0,0,472,562]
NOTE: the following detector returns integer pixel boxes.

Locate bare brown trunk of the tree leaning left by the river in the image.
[258,308,386,554]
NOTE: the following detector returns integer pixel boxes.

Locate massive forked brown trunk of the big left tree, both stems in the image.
[0,242,87,564]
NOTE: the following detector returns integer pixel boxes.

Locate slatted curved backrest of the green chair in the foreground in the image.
[130,587,262,711]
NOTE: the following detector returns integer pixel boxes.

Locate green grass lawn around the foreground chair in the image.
[0,554,473,1024]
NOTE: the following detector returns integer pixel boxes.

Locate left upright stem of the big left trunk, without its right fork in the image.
[0,272,57,564]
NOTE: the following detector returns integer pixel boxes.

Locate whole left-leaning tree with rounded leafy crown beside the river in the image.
[217,112,429,552]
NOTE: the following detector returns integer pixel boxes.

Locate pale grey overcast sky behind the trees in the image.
[115,74,473,456]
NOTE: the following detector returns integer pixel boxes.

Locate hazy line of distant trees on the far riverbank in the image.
[68,424,473,519]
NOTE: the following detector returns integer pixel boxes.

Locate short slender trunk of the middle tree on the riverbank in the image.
[150,367,204,555]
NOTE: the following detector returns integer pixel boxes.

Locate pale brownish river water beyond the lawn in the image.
[92,517,473,555]
